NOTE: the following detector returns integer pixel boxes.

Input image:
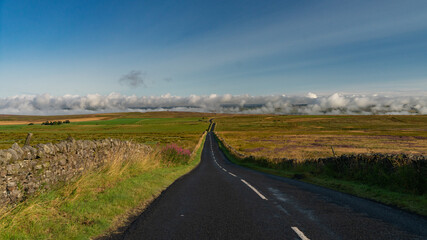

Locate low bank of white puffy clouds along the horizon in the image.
[0,93,427,115]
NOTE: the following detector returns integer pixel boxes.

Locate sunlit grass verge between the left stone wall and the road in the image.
[0,132,205,239]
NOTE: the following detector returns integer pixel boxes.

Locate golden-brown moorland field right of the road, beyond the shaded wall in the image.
[215,115,427,160]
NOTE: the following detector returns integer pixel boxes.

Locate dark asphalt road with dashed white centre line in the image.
[110,124,427,240]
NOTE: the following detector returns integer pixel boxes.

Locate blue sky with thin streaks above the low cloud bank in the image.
[0,0,427,98]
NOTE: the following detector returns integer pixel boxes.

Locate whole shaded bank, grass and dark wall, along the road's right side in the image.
[217,133,427,216]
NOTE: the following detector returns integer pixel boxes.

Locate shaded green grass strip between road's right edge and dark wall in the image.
[217,134,427,216]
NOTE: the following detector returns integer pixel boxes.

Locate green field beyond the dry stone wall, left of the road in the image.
[0,112,213,149]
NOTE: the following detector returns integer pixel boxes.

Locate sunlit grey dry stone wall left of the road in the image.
[0,139,149,208]
